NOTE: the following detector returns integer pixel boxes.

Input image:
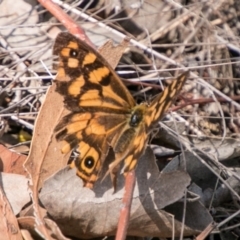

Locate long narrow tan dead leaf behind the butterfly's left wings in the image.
[24,36,129,239]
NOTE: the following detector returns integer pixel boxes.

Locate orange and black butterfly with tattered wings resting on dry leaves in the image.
[53,32,188,188]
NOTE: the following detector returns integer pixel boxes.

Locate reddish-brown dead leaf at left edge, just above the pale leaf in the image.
[0,145,27,176]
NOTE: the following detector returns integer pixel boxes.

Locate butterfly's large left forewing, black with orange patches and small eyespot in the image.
[53,33,135,111]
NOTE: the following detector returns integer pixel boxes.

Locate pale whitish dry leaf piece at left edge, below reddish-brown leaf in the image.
[0,173,31,215]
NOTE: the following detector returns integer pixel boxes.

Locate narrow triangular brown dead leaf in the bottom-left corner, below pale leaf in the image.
[0,181,22,240]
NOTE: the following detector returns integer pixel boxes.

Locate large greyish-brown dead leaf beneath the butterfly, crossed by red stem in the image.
[40,149,212,238]
